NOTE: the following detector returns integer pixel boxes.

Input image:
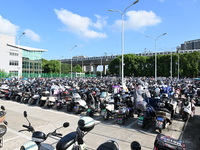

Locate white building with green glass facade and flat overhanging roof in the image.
[0,34,46,77]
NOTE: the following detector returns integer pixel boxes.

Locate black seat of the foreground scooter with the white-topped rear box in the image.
[56,132,77,150]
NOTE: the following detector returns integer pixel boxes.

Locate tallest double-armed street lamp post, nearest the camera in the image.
[108,0,139,89]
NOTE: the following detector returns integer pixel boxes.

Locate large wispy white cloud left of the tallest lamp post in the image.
[54,9,107,38]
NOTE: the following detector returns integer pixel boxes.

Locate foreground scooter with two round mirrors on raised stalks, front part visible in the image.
[19,111,69,150]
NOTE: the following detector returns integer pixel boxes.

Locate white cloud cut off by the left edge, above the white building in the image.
[0,15,19,36]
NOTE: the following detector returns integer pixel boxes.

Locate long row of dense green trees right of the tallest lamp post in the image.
[108,51,200,77]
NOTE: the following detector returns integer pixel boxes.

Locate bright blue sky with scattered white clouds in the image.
[0,0,200,60]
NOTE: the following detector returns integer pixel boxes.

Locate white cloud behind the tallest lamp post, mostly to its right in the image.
[114,10,161,31]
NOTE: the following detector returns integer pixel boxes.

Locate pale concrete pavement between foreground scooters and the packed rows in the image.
[0,100,197,150]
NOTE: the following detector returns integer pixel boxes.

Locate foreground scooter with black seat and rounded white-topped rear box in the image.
[56,116,95,150]
